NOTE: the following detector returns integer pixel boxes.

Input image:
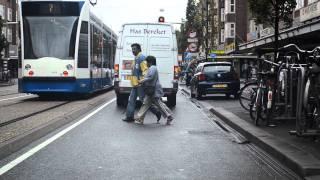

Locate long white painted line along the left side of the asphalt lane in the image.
[0,98,116,176]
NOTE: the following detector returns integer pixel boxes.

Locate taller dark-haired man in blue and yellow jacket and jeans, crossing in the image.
[122,43,161,122]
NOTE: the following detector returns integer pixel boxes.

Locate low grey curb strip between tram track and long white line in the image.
[0,89,114,159]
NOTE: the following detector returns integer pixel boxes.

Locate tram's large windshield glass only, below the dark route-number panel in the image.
[24,17,78,59]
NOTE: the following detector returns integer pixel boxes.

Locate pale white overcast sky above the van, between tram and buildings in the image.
[94,0,188,34]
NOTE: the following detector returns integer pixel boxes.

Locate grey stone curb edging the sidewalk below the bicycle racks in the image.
[209,108,320,179]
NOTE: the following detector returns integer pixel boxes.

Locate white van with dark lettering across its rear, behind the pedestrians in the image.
[114,23,179,106]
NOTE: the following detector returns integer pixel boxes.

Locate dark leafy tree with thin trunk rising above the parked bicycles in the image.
[249,0,297,57]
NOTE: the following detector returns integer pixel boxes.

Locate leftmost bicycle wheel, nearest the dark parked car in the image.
[239,82,258,111]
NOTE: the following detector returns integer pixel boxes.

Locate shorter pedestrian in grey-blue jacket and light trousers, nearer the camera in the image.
[135,56,173,125]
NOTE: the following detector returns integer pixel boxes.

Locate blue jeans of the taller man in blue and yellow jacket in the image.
[126,86,161,118]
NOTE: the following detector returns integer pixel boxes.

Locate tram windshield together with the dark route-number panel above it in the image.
[22,1,84,59]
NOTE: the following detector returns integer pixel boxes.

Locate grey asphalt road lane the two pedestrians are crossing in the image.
[0,90,293,180]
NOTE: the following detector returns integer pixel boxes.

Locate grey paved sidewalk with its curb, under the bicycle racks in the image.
[180,85,320,180]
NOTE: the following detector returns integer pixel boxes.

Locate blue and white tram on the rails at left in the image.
[19,0,117,95]
